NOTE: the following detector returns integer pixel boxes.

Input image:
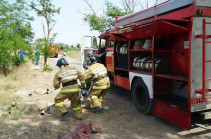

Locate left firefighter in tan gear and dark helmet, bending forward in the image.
[53,58,84,120]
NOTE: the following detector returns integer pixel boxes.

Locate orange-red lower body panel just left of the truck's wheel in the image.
[115,76,130,90]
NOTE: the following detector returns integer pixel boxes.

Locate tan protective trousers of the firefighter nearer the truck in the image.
[90,88,109,108]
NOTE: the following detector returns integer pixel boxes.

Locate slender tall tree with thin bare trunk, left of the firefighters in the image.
[26,0,60,66]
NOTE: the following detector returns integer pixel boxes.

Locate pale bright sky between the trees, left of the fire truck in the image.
[31,0,117,45]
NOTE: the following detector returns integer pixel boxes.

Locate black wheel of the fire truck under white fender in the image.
[132,78,153,114]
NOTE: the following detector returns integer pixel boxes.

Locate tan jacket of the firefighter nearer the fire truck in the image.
[84,63,110,89]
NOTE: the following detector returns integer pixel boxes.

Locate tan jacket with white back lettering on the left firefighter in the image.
[53,66,85,93]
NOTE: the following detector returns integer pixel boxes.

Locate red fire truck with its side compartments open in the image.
[98,0,211,129]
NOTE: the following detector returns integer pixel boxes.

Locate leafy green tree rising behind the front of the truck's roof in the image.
[84,0,132,32]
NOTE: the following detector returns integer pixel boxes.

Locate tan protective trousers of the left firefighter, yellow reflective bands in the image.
[54,92,82,118]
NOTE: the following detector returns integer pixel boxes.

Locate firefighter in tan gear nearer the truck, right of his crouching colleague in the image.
[84,55,110,113]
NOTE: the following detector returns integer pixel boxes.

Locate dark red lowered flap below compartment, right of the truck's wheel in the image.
[154,100,191,130]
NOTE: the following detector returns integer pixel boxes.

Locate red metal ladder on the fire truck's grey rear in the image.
[196,19,211,99]
